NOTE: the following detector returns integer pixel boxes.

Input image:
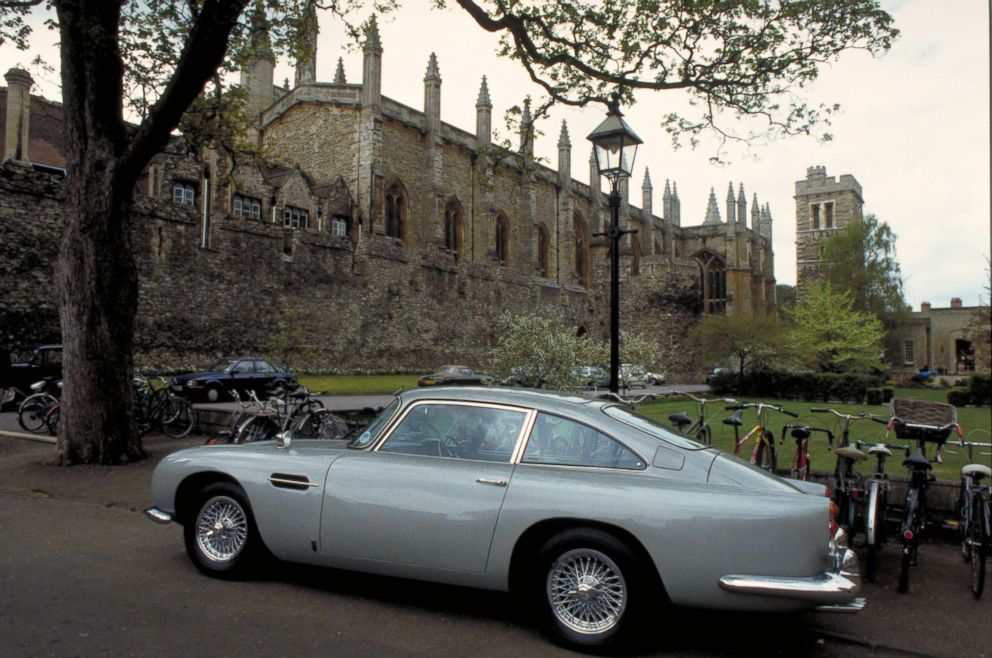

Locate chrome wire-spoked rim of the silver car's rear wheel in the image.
[546,548,627,633]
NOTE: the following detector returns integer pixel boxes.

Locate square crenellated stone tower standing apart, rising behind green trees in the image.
[794,167,864,290]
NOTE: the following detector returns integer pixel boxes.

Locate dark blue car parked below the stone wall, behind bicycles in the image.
[171,356,296,402]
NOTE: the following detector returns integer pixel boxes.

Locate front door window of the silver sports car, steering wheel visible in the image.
[379,404,527,464]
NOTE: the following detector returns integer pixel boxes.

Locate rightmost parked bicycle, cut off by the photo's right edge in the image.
[948,430,992,599]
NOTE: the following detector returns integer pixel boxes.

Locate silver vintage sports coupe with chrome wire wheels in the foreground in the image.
[147,388,864,646]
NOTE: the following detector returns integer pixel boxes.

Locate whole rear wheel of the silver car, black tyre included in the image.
[532,528,647,647]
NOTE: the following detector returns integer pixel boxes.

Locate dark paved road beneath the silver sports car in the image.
[0,436,992,658]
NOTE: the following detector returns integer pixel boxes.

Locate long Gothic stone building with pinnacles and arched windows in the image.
[0,22,775,370]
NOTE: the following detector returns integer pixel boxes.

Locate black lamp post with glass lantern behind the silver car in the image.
[587,92,643,394]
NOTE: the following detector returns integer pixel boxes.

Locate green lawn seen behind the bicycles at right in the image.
[638,389,992,480]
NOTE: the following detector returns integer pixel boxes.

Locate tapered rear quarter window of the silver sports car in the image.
[522,413,644,469]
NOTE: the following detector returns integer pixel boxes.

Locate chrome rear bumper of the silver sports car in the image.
[720,530,865,612]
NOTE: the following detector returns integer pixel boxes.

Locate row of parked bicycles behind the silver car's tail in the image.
[625,391,992,598]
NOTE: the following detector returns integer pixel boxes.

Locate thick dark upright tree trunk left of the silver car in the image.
[55,0,144,465]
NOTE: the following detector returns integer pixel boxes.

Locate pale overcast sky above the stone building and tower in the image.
[0,0,992,309]
